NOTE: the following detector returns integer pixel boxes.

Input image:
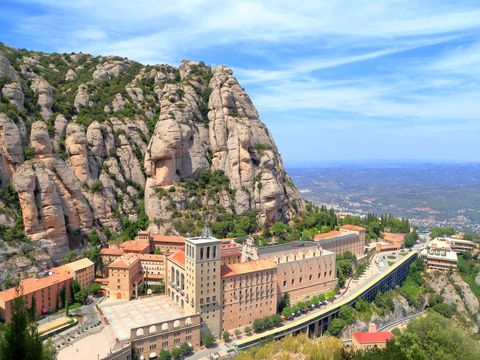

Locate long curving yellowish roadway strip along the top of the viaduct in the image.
[235,251,418,350]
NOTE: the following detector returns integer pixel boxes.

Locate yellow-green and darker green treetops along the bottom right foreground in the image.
[236,311,480,360]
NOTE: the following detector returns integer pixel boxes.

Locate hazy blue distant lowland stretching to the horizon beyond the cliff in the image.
[289,163,480,232]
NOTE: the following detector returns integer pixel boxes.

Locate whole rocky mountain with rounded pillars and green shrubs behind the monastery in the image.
[0,45,304,266]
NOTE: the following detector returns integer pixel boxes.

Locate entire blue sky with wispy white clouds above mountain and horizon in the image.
[0,0,480,166]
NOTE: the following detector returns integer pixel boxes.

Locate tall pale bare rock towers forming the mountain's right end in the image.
[145,62,303,223]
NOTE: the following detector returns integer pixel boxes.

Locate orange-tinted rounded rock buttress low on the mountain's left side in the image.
[13,121,93,260]
